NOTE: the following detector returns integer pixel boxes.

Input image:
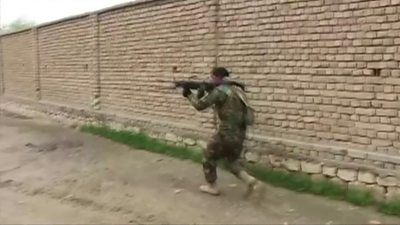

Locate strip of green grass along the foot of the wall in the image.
[81,125,400,217]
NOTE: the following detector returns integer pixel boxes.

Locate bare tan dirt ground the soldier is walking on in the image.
[0,113,400,224]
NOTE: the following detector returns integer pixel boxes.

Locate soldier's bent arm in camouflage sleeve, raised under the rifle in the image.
[188,88,226,111]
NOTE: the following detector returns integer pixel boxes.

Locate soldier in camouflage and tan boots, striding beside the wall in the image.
[182,67,258,195]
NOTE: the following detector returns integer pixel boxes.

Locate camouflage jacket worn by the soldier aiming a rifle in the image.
[188,84,246,135]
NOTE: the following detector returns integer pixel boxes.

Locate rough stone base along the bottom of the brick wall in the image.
[0,97,400,200]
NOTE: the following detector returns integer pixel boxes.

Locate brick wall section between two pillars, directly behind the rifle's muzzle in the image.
[99,0,214,130]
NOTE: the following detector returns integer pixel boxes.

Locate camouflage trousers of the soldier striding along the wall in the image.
[202,132,246,184]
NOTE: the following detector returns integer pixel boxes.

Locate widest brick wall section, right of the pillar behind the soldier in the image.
[218,0,400,168]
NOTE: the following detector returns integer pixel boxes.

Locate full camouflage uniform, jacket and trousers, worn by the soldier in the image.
[188,84,246,184]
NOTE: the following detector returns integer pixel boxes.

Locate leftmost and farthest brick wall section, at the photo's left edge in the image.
[1,31,35,99]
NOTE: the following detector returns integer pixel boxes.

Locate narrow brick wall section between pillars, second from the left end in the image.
[37,16,93,107]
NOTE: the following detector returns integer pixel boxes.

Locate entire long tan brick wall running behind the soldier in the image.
[0,0,400,195]
